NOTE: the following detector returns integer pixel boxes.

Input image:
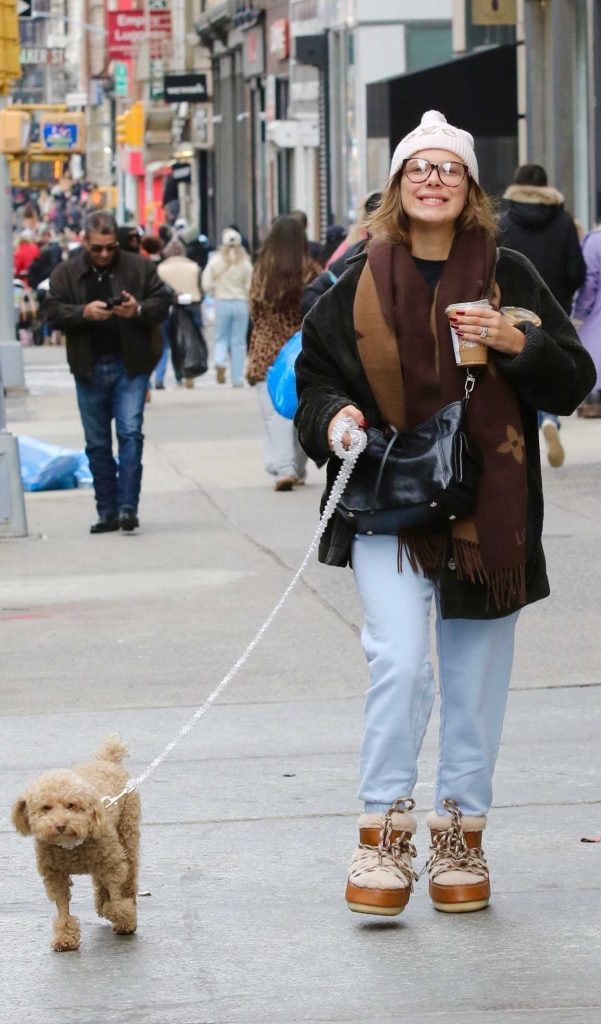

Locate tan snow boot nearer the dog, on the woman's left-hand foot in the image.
[346,798,418,916]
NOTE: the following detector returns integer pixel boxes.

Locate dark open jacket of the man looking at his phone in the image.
[44,249,172,380]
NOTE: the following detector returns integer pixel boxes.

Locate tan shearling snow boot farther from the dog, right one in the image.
[426,800,490,913]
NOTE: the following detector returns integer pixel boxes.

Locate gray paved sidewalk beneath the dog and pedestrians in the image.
[0,348,601,1024]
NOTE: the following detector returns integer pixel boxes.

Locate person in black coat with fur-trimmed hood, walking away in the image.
[500,164,587,468]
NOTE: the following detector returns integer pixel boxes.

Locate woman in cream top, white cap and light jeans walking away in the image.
[203,227,253,387]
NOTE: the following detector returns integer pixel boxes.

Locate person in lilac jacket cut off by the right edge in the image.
[573,228,601,411]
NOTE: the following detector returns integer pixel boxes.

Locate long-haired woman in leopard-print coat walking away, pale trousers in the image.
[247,216,321,492]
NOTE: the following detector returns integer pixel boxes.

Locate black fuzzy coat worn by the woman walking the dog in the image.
[295,249,596,618]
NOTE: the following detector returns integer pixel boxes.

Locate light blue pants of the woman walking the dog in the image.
[352,535,518,814]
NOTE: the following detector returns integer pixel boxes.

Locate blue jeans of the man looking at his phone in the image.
[76,356,148,520]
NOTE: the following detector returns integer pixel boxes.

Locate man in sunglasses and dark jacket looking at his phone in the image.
[44,211,171,534]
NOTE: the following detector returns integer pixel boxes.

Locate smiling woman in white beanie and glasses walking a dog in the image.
[297,111,595,914]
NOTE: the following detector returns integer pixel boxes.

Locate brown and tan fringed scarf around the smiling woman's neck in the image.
[354,229,526,610]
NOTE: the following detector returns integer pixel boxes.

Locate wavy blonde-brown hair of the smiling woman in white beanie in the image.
[361,164,499,251]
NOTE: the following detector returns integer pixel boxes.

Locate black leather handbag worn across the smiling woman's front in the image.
[337,393,482,534]
